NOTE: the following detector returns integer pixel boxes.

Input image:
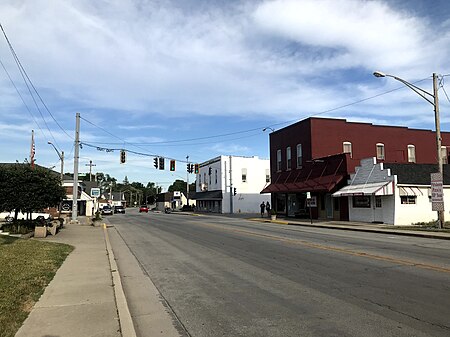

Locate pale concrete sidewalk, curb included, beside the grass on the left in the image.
[16,218,135,337]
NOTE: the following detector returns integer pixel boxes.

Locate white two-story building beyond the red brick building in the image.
[195,156,270,213]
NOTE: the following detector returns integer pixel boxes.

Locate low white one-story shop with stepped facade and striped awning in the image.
[333,158,450,225]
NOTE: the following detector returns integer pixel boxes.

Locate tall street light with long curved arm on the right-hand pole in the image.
[373,71,444,228]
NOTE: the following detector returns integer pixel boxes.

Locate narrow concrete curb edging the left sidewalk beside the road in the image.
[102,223,136,337]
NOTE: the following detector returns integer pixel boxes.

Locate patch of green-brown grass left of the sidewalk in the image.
[0,236,73,337]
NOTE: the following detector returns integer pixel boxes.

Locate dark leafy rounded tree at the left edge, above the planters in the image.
[0,164,66,220]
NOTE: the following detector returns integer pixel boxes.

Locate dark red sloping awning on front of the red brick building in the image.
[260,174,344,193]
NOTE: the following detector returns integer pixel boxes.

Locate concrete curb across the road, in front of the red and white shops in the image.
[248,218,450,240]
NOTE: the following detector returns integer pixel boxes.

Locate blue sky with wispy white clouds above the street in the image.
[0,0,450,189]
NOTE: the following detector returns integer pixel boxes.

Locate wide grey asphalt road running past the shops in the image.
[109,210,450,337]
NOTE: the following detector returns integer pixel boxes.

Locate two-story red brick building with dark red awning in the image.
[262,118,450,220]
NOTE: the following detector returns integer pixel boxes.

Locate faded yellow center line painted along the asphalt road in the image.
[195,223,450,274]
